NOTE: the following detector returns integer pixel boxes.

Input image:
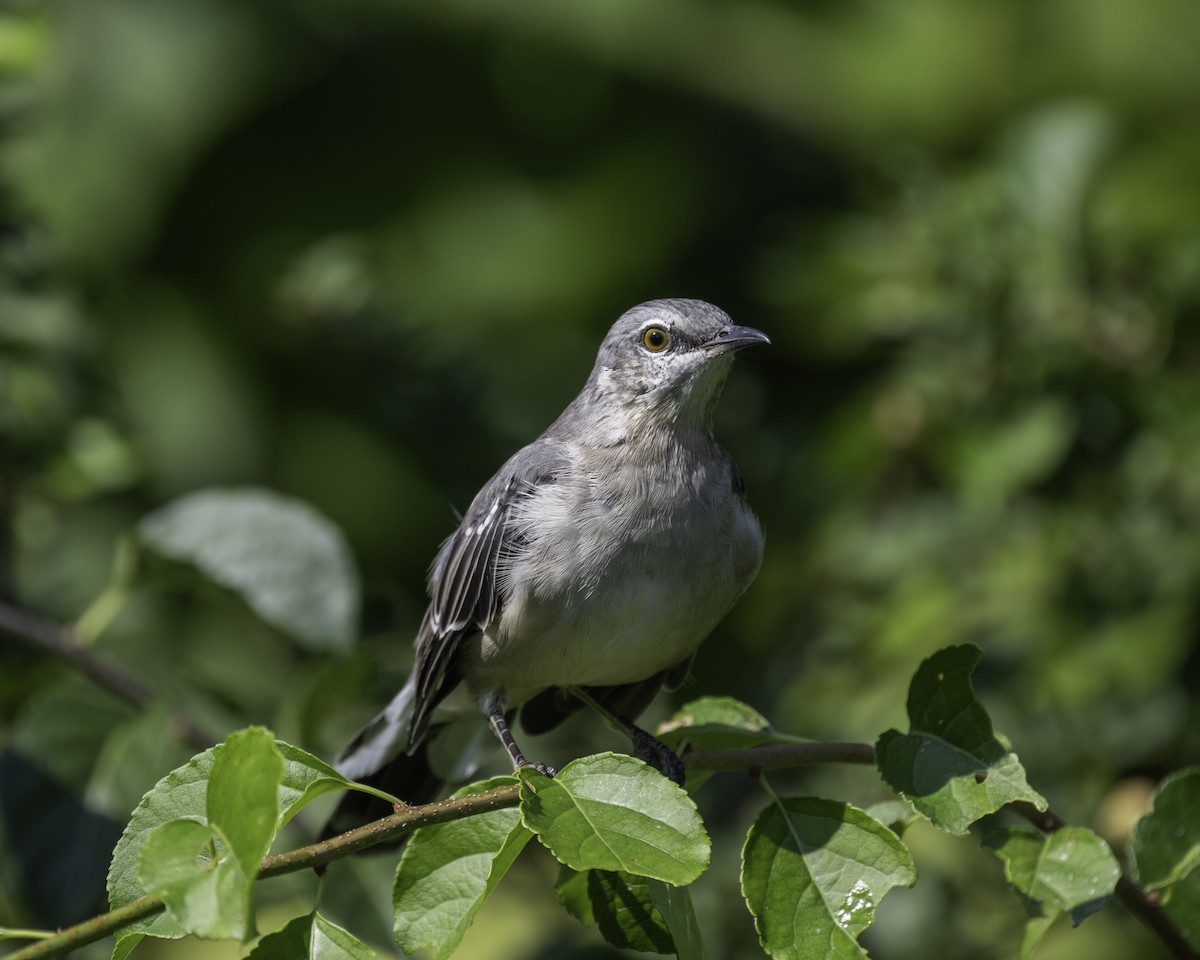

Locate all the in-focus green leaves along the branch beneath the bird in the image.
[14,612,1200,960]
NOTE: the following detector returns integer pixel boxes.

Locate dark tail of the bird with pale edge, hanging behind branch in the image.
[319,678,444,840]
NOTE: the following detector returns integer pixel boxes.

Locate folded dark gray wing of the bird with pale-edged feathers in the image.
[408,438,568,749]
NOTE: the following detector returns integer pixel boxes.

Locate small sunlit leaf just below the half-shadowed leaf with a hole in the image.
[983,827,1121,949]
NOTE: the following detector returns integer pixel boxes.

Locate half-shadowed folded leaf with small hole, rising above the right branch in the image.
[875,646,1046,836]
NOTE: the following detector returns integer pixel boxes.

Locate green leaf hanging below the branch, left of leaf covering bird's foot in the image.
[391,776,530,958]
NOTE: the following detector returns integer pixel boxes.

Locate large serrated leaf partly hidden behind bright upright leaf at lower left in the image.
[108,734,343,949]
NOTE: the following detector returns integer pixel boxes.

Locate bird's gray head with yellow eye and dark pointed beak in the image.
[584,300,770,427]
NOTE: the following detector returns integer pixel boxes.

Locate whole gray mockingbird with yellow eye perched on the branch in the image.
[329,300,769,830]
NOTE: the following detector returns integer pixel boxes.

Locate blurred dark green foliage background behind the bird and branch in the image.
[0,0,1200,960]
